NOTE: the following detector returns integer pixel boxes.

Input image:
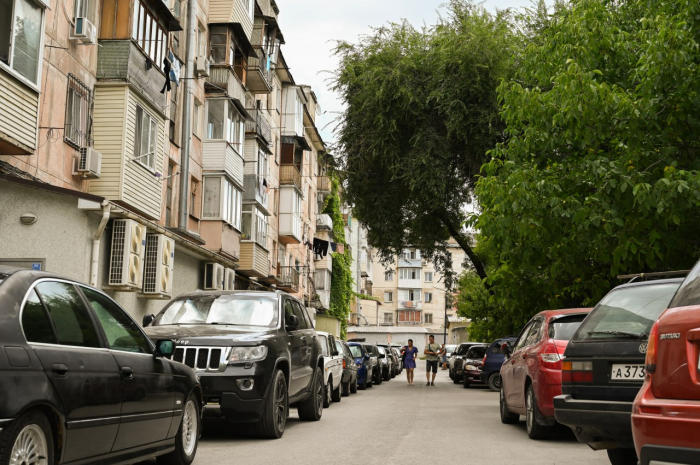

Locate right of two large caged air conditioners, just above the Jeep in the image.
[143,234,175,297]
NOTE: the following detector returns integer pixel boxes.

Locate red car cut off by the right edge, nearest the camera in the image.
[632,262,700,465]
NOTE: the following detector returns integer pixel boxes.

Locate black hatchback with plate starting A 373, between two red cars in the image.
[554,279,682,465]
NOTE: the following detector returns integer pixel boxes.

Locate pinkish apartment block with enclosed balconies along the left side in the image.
[0,0,332,317]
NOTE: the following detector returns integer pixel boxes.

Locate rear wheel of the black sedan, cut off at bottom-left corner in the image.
[0,411,54,465]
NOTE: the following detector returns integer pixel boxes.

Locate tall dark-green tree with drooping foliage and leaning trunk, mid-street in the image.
[333,0,518,284]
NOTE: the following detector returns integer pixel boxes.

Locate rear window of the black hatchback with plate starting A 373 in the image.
[574,282,680,341]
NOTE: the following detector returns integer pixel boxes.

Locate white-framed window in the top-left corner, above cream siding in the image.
[0,0,44,84]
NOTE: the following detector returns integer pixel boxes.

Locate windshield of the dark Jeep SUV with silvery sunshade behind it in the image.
[155,294,277,328]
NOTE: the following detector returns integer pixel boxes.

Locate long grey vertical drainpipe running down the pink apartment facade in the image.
[177,0,197,231]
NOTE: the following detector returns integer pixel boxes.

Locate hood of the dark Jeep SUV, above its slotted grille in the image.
[144,325,271,345]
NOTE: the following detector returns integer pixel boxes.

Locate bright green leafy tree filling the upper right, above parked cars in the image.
[460,0,700,335]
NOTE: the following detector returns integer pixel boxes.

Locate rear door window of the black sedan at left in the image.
[36,281,100,347]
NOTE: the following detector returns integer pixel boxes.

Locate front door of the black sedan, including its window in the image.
[80,286,176,452]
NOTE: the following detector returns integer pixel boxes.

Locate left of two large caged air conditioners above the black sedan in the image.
[108,219,146,289]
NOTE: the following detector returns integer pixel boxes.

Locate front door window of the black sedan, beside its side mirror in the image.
[81,287,151,354]
